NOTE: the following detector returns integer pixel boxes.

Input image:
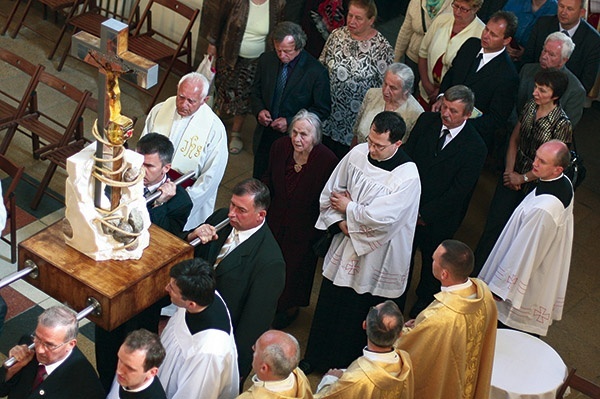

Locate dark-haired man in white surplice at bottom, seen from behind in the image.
[158,258,240,399]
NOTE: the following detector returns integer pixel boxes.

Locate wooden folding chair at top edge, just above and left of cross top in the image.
[48,0,140,71]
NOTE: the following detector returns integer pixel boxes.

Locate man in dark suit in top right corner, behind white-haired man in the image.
[523,0,600,93]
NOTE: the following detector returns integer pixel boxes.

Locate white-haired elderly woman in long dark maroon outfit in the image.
[263,110,338,328]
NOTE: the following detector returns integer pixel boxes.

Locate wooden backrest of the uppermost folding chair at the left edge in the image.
[0,48,44,124]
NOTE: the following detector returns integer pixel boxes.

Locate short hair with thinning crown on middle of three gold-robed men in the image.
[366,299,404,348]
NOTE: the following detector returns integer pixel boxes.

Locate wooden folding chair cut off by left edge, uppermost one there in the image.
[0,48,44,154]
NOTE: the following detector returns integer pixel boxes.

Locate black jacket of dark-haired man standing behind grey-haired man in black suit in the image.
[440,37,519,148]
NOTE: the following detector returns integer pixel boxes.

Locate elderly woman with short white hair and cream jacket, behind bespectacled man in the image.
[352,63,424,146]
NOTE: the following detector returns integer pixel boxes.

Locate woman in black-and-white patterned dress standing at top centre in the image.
[320,0,393,158]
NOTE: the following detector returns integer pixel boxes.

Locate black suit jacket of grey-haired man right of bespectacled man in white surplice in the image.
[404,112,487,237]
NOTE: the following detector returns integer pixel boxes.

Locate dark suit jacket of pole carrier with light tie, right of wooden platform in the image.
[196,208,285,376]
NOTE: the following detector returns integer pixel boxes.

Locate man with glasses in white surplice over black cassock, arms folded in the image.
[300,111,421,372]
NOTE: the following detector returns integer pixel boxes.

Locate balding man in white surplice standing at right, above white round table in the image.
[479,140,573,335]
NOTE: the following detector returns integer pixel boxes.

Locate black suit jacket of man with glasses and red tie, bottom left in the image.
[0,347,106,399]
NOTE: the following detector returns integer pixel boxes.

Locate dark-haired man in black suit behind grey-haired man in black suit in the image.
[432,11,519,153]
